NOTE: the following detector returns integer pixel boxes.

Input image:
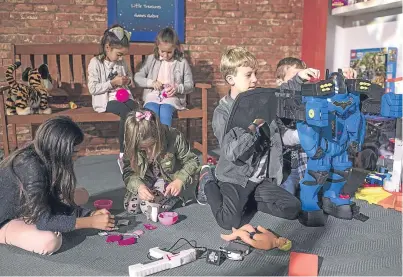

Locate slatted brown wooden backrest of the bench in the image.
[14,43,154,96]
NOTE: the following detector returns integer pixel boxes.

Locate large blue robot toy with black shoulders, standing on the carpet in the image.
[294,70,402,226]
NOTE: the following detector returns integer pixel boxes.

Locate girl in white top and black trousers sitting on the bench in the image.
[88,25,138,171]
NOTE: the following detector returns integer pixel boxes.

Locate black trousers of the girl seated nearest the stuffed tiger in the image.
[106,99,138,153]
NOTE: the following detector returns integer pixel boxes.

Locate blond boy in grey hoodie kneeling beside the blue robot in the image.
[197,47,301,229]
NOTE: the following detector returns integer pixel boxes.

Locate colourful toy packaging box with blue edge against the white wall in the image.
[350,47,397,93]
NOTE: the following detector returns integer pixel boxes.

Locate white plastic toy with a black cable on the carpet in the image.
[129,247,196,277]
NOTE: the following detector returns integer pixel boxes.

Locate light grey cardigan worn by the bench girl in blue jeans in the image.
[134,54,194,106]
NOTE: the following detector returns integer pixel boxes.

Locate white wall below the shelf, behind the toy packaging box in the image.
[326,8,403,77]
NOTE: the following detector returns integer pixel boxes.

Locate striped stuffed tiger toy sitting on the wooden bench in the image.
[6,62,52,115]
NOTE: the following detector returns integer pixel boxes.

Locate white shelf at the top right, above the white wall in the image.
[332,0,402,16]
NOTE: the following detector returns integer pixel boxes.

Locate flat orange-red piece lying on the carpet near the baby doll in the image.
[288,252,319,276]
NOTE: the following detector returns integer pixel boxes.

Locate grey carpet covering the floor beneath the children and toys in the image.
[0,156,402,276]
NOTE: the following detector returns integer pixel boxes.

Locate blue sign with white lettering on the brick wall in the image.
[108,0,185,42]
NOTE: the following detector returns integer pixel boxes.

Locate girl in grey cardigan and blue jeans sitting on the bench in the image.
[134,28,194,126]
